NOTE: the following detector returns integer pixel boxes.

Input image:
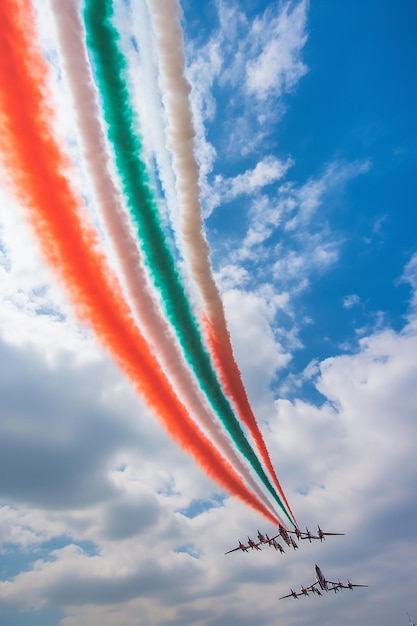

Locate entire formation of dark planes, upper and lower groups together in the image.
[225,524,368,600]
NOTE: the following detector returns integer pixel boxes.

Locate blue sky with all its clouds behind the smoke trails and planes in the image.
[0,0,417,626]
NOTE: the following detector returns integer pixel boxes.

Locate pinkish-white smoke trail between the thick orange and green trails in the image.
[50,0,279,519]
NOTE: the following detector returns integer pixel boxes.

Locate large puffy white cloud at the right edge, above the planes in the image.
[268,314,417,532]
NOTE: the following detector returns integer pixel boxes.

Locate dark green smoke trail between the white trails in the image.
[84,0,292,522]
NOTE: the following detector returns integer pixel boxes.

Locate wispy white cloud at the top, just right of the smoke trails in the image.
[187,0,308,200]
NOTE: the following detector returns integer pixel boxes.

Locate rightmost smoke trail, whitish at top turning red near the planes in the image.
[147,0,295,519]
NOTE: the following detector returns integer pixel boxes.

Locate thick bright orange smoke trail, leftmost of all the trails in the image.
[0,0,278,524]
